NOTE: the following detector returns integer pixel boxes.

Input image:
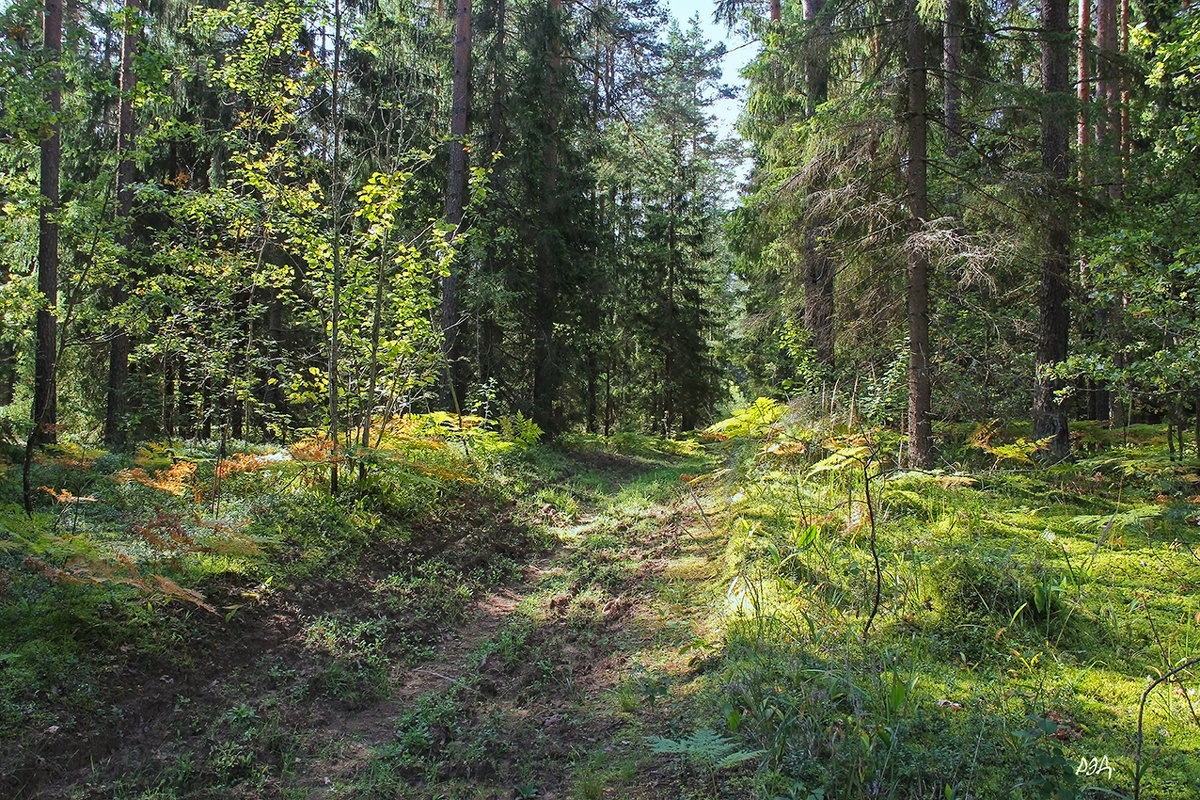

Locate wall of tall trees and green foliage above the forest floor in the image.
[0,0,1200,465]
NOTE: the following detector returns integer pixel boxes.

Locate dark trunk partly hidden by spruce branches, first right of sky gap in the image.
[804,0,834,367]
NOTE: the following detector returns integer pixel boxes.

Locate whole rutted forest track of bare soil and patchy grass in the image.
[29,443,715,800]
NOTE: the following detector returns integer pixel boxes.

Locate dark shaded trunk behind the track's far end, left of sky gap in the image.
[533,0,563,433]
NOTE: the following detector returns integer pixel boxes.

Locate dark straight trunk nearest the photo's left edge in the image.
[32,0,62,444]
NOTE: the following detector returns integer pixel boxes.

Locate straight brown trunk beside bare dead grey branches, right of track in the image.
[907,1,934,469]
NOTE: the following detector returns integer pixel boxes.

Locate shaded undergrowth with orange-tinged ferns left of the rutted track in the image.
[0,419,548,796]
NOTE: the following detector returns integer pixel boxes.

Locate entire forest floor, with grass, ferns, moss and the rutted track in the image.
[0,401,1200,800]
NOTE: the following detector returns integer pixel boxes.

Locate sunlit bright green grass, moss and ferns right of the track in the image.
[681,401,1200,799]
